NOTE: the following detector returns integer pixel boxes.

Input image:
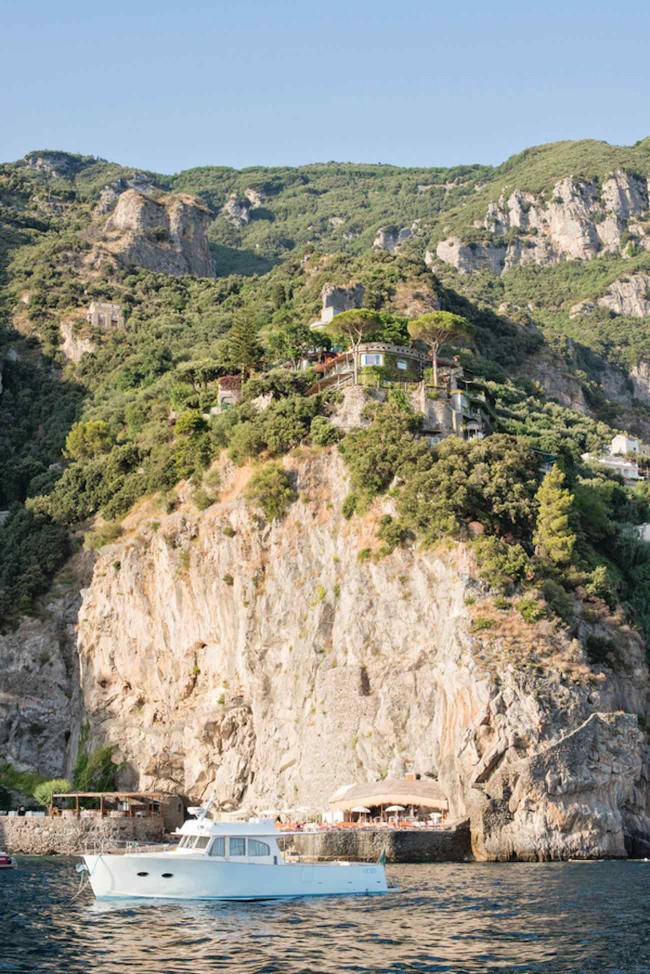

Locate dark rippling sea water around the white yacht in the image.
[0,857,650,974]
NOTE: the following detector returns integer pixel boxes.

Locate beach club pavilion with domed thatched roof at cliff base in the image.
[328,775,449,824]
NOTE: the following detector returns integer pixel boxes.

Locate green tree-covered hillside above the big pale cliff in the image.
[0,140,650,664]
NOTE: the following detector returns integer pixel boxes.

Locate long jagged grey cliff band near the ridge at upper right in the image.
[436,169,650,274]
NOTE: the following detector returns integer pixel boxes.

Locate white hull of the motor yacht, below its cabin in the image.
[84,853,388,900]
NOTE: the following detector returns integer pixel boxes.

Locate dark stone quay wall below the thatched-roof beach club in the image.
[283,823,472,862]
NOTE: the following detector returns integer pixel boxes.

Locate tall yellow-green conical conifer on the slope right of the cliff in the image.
[533,466,576,570]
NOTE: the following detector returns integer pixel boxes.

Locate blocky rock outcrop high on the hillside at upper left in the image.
[102,189,215,277]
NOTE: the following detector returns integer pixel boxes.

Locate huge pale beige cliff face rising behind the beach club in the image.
[67,453,650,859]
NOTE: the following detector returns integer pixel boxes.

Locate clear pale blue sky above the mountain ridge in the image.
[0,0,650,173]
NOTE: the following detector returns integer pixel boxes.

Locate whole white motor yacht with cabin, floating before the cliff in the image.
[78,803,388,900]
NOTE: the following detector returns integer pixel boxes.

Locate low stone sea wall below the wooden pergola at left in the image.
[0,816,163,856]
